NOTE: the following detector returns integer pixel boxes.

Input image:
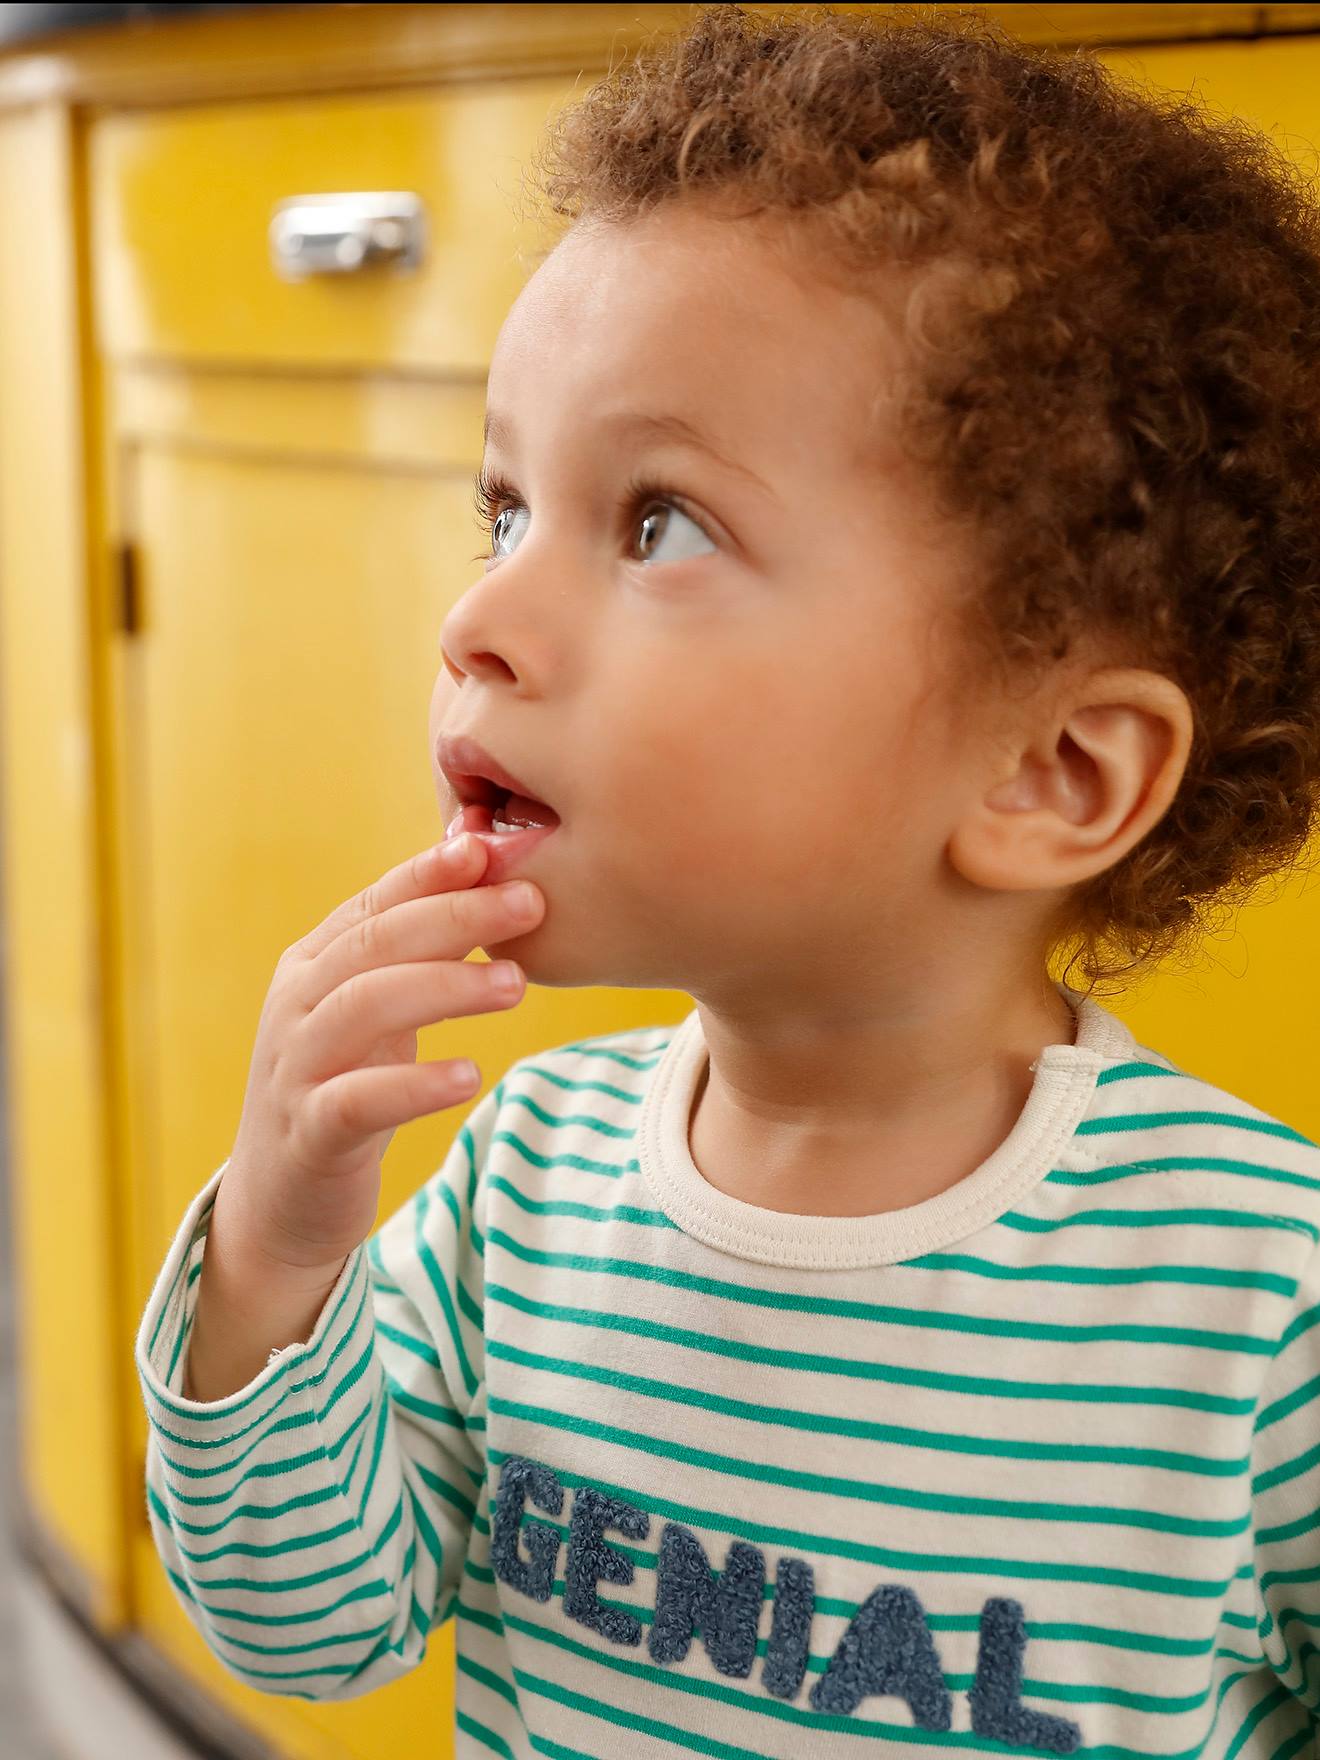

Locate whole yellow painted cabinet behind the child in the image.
[0,7,1320,1760]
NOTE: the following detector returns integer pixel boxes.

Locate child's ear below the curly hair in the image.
[949,667,1193,891]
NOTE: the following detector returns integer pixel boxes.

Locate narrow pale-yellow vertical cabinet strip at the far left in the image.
[0,109,127,1621]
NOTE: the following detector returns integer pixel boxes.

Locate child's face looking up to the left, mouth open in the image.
[429,206,984,1008]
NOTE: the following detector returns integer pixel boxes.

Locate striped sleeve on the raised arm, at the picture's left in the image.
[137,1086,502,1698]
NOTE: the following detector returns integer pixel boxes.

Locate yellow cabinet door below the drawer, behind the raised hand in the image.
[123,403,482,1760]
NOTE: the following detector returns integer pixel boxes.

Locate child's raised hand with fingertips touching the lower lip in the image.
[183,836,546,1399]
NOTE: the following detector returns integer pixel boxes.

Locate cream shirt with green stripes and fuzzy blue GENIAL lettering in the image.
[137,984,1320,1760]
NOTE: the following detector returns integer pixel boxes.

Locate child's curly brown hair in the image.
[530,5,1320,989]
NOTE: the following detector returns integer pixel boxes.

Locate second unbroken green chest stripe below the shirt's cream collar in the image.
[486,1283,1255,1417]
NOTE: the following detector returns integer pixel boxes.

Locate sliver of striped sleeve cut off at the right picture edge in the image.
[1251,1224,1320,1712]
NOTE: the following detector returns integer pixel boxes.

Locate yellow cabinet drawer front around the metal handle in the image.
[88,76,572,373]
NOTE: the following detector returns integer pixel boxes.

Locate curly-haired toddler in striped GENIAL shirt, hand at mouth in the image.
[137,5,1320,1760]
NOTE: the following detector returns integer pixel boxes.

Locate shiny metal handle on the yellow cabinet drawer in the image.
[269,190,426,282]
